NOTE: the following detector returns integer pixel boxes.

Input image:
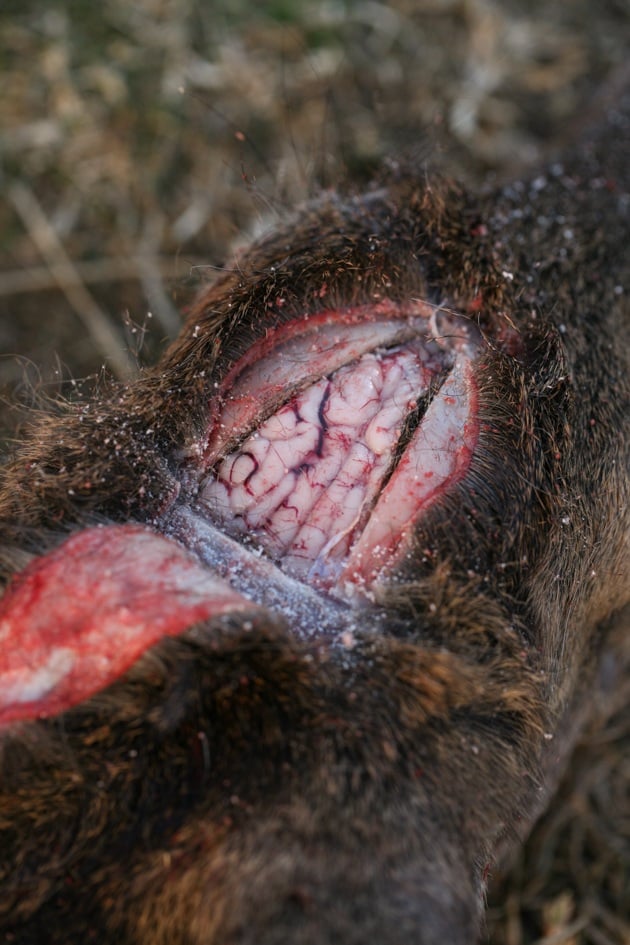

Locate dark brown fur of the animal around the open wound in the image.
[0,75,630,945]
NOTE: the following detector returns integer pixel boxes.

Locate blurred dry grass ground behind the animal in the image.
[0,0,630,945]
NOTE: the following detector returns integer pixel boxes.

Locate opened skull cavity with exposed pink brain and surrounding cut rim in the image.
[200,308,478,596]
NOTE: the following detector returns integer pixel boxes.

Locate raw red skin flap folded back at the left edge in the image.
[0,525,253,723]
